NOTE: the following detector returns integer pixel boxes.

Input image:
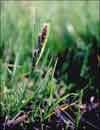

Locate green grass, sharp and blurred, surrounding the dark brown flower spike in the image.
[0,1,100,129]
